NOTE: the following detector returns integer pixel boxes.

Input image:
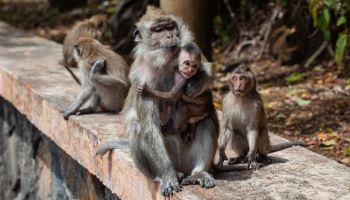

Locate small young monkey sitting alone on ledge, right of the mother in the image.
[219,64,305,169]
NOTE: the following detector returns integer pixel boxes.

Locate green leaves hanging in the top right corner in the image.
[308,0,350,68]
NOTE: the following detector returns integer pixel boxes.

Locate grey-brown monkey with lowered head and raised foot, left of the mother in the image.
[64,37,129,119]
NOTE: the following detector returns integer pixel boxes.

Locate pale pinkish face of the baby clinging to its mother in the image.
[179,51,199,79]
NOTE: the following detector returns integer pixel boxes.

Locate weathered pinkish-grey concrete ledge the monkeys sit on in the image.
[0,23,350,199]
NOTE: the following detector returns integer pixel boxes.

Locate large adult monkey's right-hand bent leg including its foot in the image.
[182,117,217,188]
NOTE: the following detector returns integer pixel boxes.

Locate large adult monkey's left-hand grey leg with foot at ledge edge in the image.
[125,104,181,196]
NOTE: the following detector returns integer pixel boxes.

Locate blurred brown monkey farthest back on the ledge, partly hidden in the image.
[63,15,107,67]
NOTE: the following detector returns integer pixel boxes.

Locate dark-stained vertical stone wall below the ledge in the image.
[0,97,118,200]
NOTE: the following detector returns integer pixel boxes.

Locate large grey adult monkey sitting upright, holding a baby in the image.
[97,7,218,196]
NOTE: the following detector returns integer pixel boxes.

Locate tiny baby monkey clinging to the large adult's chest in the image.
[138,43,210,131]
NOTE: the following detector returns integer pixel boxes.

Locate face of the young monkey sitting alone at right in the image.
[230,74,253,96]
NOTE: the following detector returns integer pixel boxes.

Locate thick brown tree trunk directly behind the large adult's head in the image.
[160,0,213,60]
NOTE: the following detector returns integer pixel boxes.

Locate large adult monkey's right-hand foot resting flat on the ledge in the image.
[181,173,215,188]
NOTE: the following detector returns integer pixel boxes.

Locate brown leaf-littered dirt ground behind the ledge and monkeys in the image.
[0,1,350,166]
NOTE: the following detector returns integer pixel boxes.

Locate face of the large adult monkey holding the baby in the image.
[149,21,180,48]
